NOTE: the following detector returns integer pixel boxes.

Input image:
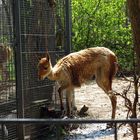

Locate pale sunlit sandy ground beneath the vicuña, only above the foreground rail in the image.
[75,79,129,119]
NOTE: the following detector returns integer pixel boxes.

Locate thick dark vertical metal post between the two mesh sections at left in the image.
[14,0,25,140]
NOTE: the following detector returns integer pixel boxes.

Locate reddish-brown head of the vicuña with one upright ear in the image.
[38,53,52,80]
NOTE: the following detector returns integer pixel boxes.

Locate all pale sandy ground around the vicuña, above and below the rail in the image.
[69,79,139,140]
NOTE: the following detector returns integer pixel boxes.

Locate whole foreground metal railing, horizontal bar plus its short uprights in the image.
[0,119,140,140]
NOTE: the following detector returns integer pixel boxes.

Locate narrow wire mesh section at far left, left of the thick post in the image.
[0,0,17,139]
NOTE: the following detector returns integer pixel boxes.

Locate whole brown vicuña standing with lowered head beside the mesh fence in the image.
[38,47,118,118]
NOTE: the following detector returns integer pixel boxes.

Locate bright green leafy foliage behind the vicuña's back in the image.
[72,0,132,70]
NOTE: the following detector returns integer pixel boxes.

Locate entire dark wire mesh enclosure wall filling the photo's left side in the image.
[0,0,71,140]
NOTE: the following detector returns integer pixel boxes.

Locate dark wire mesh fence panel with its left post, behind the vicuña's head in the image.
[14,0,70,139]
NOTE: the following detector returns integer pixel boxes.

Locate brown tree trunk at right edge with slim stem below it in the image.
[127,0,140,140]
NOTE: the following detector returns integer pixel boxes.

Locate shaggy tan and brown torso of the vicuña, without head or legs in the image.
[54,47,117,87]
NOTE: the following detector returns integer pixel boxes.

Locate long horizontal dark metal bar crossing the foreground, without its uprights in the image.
[0,118,140,124]
